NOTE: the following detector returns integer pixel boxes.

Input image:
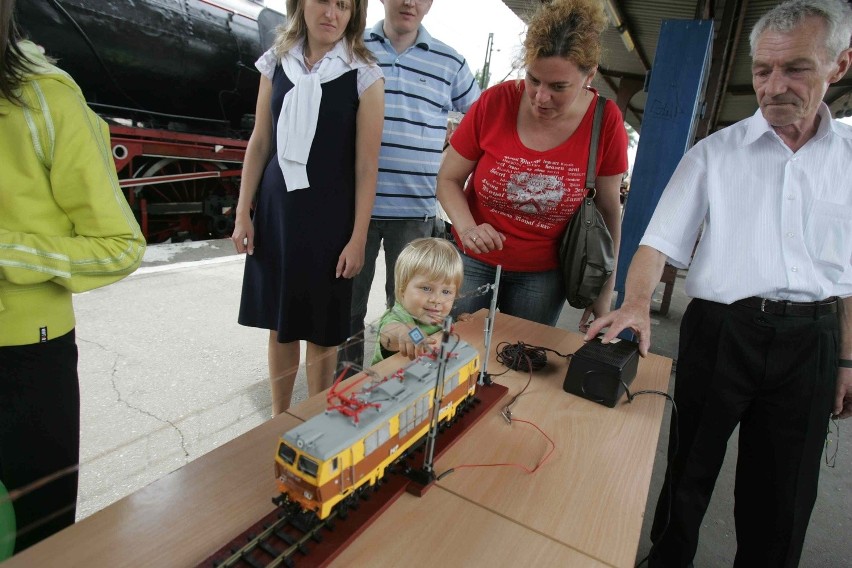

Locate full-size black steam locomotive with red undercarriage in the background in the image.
[16,0,286,242]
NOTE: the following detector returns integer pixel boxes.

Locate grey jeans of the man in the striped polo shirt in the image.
[341,217,435,364]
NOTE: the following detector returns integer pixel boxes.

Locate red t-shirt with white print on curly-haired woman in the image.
[450,81,627,272]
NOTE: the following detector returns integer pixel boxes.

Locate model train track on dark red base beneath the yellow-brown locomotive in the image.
[199,384,508,568]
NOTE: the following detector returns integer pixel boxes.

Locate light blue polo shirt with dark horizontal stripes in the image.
[364,20,479,220]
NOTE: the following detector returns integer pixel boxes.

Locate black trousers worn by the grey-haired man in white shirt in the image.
[649,300,839,568]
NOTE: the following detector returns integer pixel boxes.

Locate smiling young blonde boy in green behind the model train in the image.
[372,238,464,364]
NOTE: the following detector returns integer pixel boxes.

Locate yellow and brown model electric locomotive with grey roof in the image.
[275,341,479,519]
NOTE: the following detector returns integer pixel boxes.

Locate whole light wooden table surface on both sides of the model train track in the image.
[3,311,671,568]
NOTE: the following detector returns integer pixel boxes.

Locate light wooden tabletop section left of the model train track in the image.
[0,414,300,568]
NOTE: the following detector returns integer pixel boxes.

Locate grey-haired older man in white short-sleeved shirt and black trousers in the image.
[587,0,852,567]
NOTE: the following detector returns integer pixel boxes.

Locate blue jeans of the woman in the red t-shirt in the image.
[452,253,565,326]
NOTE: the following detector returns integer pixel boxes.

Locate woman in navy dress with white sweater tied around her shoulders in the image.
[232,0,384,414]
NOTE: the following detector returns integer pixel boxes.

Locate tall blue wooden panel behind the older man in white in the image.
[615,20,713,306]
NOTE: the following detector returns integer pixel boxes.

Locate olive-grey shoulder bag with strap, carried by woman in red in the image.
[559,96,615,309]
